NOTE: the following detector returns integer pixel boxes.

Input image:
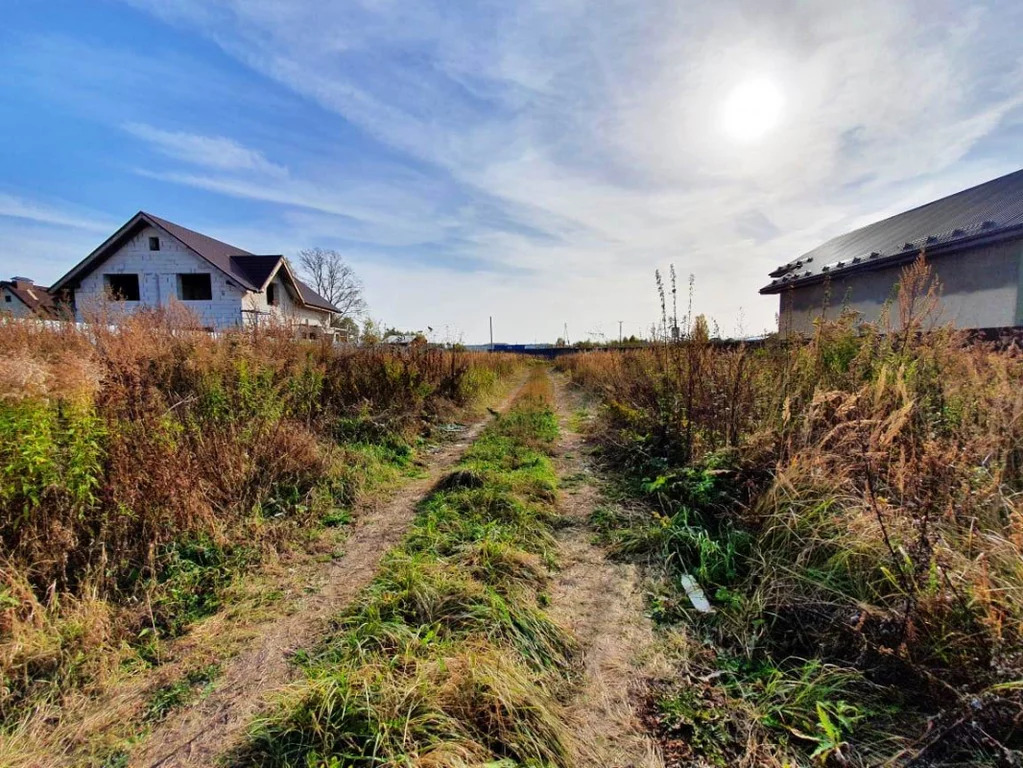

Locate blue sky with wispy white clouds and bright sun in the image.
[0,0,1023,343]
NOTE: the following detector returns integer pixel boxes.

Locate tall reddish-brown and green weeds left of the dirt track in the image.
[0,314,520,744]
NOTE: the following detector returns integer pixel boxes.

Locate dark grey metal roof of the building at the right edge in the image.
[760,171,1023,293]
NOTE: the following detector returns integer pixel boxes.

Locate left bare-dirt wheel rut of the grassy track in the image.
[130,378,519,768]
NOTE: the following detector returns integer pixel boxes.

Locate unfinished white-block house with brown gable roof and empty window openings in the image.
[50,211,340,338]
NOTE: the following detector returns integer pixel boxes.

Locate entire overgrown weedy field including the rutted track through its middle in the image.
[0,260,1023,768]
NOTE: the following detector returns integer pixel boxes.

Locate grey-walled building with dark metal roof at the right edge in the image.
[760,171,1023,335]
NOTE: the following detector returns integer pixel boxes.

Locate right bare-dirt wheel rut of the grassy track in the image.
[551,376,664,768]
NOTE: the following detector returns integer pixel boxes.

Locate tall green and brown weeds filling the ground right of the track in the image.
[561,261,1023,766]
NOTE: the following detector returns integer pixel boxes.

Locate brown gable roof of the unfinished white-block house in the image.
[51,211,341,312]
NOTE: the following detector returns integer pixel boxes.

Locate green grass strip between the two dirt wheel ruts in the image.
[231,368,579,768]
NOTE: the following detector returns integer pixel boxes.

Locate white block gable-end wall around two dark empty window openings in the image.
[75,227,247,329]
